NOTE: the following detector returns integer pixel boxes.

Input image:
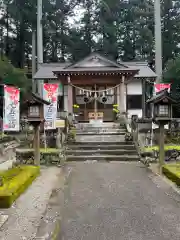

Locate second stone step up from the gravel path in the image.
[66,149,137,156]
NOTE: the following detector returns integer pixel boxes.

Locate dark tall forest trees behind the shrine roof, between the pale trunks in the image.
[0,0,180,66]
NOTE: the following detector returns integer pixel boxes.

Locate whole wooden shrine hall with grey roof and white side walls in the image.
[34,53,156,122]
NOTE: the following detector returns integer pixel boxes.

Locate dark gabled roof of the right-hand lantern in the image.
[146,89,178,104]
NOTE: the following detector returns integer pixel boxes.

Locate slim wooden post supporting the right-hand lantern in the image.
[159,122,165,174]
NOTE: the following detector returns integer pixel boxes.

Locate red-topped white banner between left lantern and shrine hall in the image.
[43,83,59,130]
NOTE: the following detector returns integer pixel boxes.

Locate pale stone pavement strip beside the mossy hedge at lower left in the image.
[0,167,61,240]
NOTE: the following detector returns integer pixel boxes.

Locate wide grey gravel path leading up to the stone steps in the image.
[58,162,180,240]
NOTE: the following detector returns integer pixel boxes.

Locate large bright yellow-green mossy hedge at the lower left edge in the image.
[0,166,40,208]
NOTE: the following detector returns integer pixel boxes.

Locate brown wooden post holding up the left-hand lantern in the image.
[34,123,40,166]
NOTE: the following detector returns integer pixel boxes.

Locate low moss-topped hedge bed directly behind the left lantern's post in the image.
[16,148,62,165]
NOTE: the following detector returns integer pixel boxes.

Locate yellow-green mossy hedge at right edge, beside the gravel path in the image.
[162,164,180,186]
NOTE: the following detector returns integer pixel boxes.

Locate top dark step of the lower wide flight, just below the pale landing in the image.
[73,140,134,146]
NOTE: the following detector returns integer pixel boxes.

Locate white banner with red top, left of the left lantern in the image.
[3,85,20,131]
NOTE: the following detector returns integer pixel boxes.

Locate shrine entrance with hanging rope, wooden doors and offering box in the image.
[73,84,117,122]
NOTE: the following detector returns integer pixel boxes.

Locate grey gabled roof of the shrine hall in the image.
[33,53,156,80]
